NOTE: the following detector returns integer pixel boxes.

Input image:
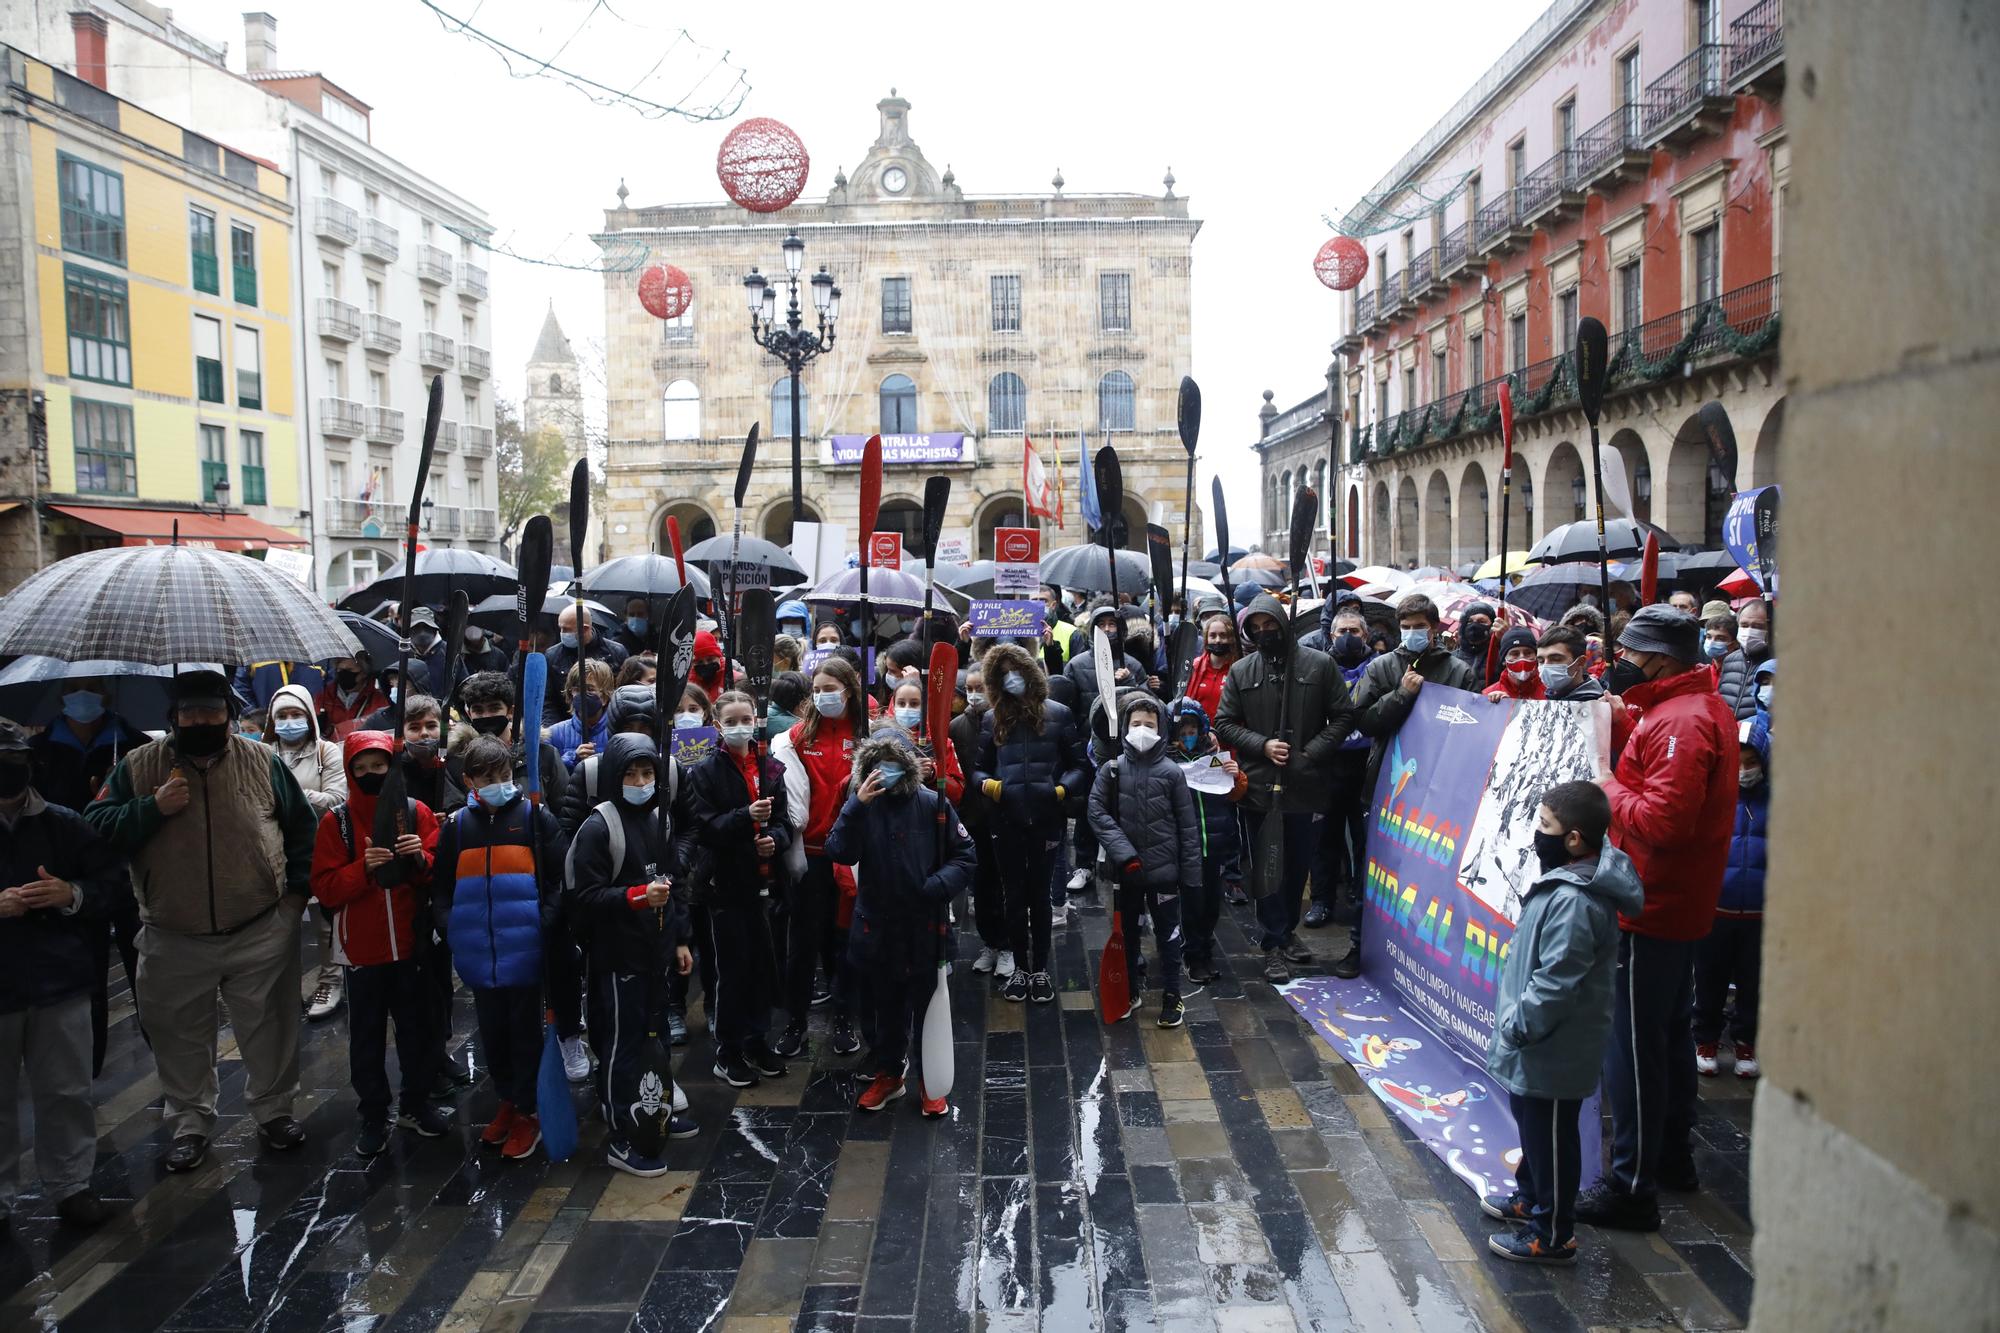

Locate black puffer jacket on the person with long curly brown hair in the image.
[972,642,1090,835]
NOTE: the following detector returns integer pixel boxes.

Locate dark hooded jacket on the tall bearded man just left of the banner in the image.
[1216,592,1354,813]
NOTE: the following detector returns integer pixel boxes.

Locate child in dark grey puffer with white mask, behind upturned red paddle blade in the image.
[1090,691,1202,1027]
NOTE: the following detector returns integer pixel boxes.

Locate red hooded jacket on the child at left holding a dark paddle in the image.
[312,731,438,967]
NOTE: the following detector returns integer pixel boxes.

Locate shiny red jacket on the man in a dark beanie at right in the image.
[1604,671,1738,941]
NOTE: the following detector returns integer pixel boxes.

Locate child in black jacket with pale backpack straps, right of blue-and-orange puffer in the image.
[566,733,700,1177]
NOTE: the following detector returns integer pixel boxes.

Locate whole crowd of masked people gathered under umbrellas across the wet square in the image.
[0,564,1776,1261]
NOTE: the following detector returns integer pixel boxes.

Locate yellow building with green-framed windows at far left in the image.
[0,46,306,590]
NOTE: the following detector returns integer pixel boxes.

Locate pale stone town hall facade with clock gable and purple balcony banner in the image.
[596,94,1200,554]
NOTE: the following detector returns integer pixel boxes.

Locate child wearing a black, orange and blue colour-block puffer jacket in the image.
[436,737,562,1159]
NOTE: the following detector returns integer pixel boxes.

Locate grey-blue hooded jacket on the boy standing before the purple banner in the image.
[1486,843,1646,1101]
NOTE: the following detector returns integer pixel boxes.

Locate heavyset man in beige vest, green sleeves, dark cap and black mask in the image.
[86,671,314,1171]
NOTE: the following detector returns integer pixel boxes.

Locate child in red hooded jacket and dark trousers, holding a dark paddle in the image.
[312,731,446,1157]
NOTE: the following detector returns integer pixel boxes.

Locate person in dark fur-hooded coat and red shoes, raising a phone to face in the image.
[826,731,976,1115]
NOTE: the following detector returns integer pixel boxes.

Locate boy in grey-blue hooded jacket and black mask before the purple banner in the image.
[1480,783,1644,1263]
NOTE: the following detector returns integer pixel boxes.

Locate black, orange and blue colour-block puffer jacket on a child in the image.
[434,797,562,991]
